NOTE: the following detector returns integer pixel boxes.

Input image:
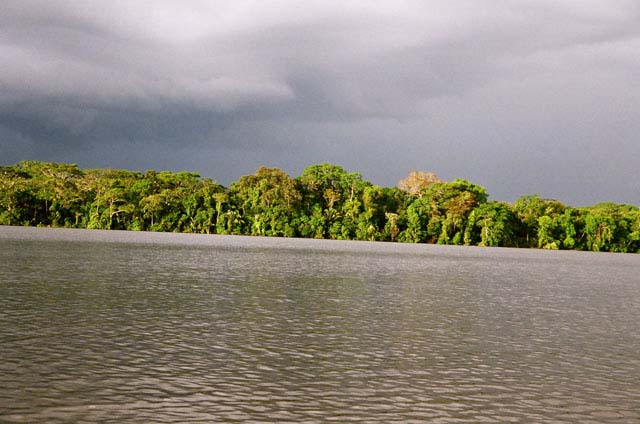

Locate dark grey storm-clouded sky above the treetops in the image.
[0,0,640,206]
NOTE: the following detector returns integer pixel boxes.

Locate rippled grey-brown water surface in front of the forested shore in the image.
[0,227,640,423]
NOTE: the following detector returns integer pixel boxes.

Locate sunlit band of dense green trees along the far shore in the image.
[0,161,640,253]
